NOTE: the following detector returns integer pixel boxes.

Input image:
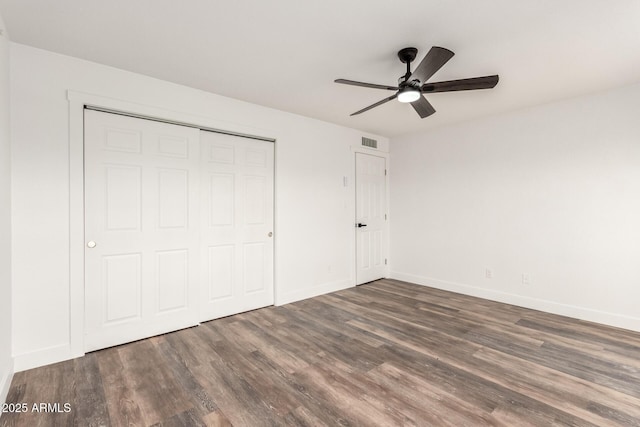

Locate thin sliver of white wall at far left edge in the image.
[0,10,13,404]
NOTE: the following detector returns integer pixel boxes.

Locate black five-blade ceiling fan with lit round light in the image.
[335,46,498,119]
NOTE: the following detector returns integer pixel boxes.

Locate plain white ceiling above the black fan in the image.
[0,0,640,136]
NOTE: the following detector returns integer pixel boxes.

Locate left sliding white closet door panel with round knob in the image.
[85,111,200,351]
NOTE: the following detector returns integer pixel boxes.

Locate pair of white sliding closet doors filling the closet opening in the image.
[84,110,274,351]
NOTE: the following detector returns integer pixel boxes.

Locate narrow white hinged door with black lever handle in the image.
[356,153,387,285]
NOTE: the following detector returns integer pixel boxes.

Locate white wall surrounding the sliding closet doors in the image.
[11,44,388,370]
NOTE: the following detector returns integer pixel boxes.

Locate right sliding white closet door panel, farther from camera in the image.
[200,132,274,321]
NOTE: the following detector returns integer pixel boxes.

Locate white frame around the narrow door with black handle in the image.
[351,145,391,286]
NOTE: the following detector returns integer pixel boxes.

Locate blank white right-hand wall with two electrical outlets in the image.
[391,85,640,330]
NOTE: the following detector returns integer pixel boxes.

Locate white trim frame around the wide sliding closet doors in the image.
[67,90,278,358]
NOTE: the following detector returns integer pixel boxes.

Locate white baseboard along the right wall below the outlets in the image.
[390,271,640,332]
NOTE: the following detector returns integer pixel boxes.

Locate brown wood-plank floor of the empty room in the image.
[0,280,640,427]
